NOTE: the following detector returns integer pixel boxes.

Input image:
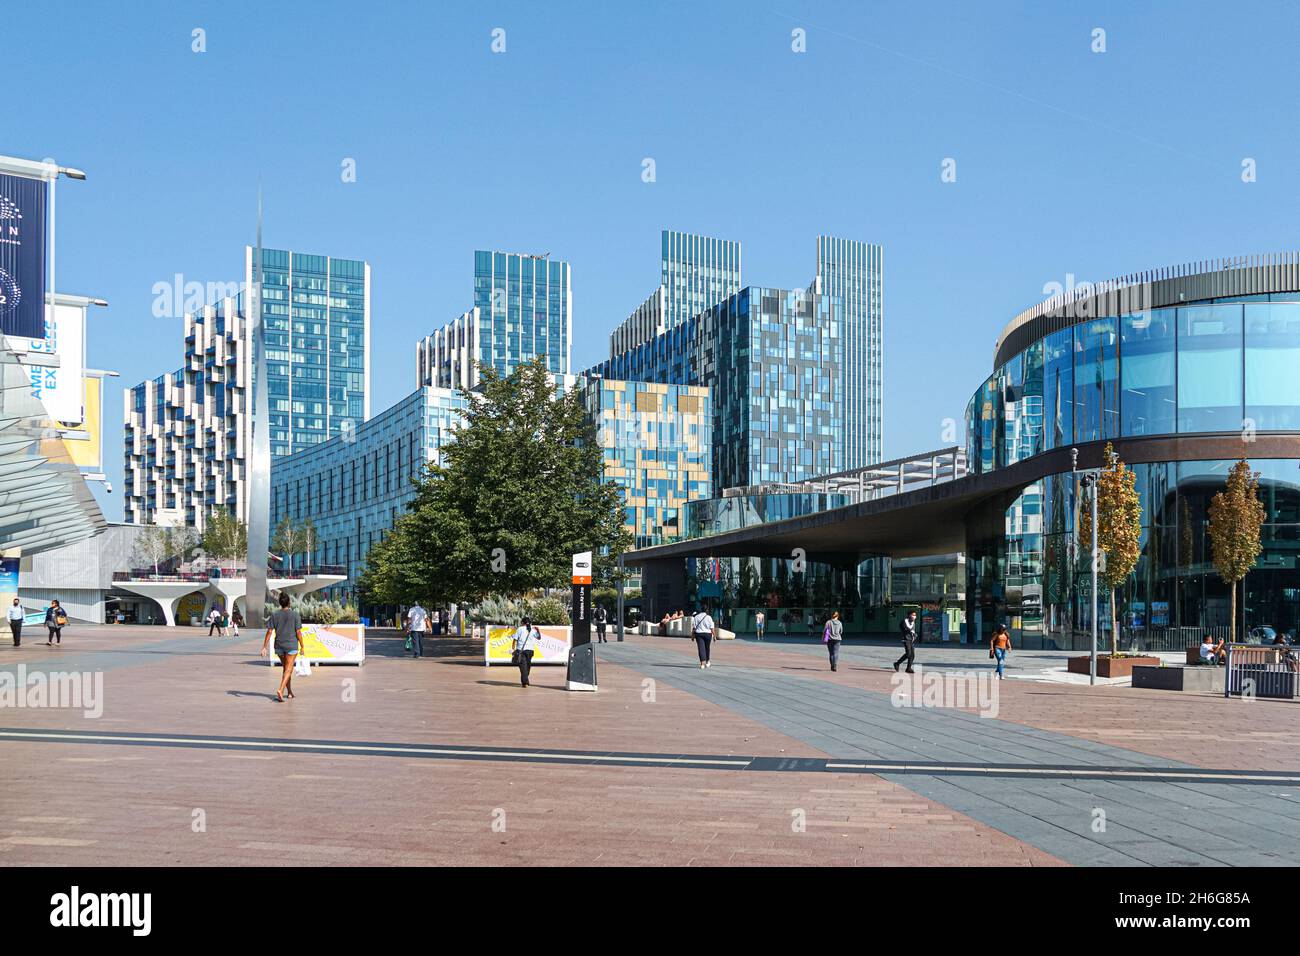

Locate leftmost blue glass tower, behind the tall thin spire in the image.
[244,247,371,455]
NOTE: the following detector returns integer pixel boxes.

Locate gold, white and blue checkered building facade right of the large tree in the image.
[584,378,712,548]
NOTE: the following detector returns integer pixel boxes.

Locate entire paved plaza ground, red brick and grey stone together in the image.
[0,626,1300,866]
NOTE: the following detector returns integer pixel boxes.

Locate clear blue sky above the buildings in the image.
[12,0,1300,520]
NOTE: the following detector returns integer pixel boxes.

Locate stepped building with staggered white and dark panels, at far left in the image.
[122,295,252,531]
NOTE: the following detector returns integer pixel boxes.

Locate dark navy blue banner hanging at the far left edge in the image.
[0,176,49,338]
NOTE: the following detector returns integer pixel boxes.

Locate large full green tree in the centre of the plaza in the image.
[363,360,632,604]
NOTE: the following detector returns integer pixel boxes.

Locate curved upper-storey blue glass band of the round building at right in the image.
[966,293,1300,473]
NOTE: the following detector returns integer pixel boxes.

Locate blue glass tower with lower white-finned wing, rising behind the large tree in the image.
[416,250,573,388]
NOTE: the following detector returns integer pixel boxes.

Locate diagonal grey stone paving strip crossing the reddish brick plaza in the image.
[599,639,1300,866]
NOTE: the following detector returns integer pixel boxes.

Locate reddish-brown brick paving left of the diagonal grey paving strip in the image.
[0,626,1061,865]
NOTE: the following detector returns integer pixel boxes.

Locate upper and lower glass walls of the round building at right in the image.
[966,283,1300,650]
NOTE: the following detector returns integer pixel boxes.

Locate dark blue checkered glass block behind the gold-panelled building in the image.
[595,286,844,494]
